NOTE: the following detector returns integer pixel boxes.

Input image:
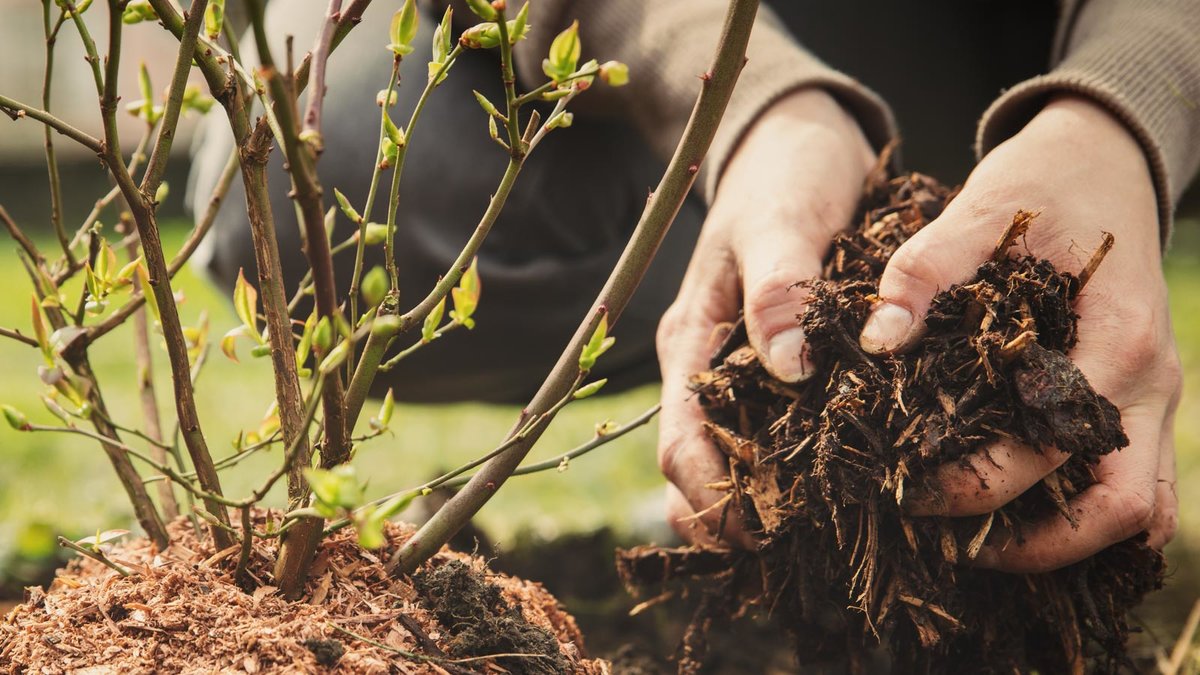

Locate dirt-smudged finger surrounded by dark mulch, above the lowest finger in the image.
[904,438,1070,516]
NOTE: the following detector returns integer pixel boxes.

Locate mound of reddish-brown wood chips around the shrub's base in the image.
[0,512,608,675]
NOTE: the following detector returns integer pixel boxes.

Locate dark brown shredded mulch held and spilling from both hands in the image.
[618,164,1164,673]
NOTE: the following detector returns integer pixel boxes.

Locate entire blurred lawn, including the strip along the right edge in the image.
[0,216,1200,644]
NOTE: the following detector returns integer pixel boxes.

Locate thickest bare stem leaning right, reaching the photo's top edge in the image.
[390,0,758,574]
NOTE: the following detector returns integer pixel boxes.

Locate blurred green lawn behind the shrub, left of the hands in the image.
[0,223,662,549]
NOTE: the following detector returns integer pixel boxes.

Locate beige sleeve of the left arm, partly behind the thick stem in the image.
[517,0,895,201]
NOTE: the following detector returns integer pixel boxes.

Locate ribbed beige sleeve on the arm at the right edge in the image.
[976,0,1200,237]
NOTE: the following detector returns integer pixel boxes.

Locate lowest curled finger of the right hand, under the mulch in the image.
[974,408,1163,573]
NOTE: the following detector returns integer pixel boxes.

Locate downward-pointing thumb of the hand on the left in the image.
[738,222,823,383]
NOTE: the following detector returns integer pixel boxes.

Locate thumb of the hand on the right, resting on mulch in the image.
[859,195,1010,354]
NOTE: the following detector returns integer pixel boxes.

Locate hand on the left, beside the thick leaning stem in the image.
[658,89,876,546]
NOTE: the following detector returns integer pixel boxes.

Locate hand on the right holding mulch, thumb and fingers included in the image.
[860,97,1182,572]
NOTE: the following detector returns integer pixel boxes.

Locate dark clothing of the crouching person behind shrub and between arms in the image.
[191,0,1055,402]
